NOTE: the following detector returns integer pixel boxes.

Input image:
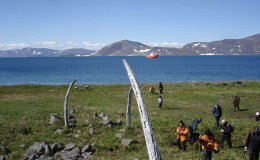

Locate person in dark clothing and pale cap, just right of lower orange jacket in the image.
[219,119,232,149]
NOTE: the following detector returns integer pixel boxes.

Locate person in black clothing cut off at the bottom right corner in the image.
[245,126,260,160]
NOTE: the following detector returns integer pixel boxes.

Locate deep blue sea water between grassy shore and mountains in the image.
[0,56,260,85]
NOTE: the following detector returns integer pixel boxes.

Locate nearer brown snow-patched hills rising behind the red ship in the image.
[95,34,260,56]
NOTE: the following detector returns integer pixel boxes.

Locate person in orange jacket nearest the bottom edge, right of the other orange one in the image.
[199,129,219,160]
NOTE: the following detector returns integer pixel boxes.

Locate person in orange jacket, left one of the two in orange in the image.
[176,120,189,151]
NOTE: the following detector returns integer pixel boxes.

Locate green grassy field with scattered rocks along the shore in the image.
[0,82,260,160]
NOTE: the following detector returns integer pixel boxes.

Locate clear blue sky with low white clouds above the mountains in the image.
[0,0,260,50]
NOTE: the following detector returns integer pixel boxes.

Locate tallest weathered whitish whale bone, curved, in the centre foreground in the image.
[123,59,161,160]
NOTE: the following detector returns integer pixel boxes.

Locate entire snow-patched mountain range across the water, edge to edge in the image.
[0,34,260,57]
